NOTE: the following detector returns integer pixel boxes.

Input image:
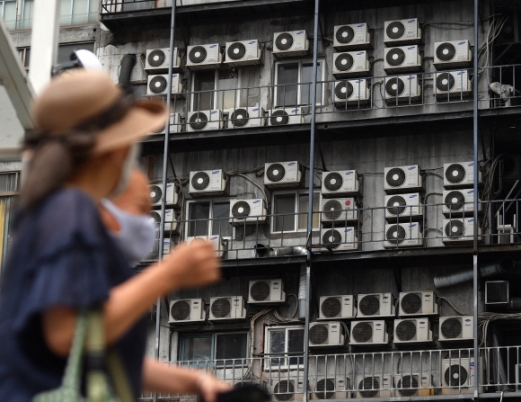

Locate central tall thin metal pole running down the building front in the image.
[303,0,320,402]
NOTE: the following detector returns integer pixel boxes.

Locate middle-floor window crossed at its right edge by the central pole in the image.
[271,190,320,233]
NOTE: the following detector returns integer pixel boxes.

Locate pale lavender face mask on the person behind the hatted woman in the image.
[101,199,156,265]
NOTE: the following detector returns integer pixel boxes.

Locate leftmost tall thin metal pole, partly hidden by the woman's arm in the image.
[153,0,176,402]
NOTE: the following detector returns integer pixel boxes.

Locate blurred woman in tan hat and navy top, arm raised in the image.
[0,70,228,402]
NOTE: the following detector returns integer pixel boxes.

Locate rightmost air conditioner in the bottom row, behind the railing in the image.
[441,355,484,395]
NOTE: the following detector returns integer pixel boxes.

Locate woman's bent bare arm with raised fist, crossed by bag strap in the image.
[42,240,220,356]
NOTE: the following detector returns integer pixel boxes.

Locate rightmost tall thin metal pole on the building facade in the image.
[472,0,481,399]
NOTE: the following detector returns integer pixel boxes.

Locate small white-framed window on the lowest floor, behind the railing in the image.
[264,325,304,368]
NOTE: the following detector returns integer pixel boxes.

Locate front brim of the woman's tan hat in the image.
[93,101,168,154]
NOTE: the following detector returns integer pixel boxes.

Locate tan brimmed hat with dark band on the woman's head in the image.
[33,70,168,153]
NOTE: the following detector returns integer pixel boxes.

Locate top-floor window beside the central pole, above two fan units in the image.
[274,60,324,107]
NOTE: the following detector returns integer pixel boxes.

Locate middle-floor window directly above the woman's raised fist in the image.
[186,200,232,237]
